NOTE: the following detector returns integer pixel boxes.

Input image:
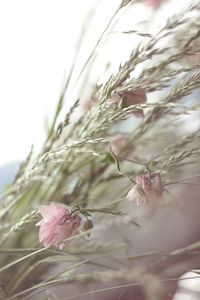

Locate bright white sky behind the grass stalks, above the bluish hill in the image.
[0,0,194,165]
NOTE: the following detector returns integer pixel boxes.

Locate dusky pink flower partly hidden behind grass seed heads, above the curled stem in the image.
[114,88,147,117]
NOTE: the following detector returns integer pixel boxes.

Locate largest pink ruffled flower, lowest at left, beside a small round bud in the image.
[36,203,81,250]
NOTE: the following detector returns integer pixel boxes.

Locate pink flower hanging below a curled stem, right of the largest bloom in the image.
[126,173,165,205]
